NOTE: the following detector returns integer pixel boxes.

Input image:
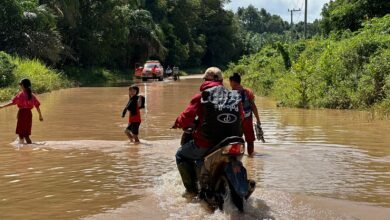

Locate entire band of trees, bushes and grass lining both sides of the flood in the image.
[0,0,390,118]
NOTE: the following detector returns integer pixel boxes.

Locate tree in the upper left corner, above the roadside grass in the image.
[0,0,63,64]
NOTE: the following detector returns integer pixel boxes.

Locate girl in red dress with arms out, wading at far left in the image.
[0,79,43,144]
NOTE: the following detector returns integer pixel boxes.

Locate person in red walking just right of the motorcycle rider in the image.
[229,73,261,156]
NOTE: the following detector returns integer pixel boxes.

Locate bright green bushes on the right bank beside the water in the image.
[228,15,390,116]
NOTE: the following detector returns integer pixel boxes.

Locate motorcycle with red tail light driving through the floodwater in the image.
[182,131,256,212]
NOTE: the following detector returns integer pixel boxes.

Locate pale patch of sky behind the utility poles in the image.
[225,0,329,23]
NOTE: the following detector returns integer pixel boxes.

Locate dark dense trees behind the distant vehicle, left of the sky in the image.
[0,0,296,69]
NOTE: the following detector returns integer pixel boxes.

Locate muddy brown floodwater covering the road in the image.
[0,78,390,219]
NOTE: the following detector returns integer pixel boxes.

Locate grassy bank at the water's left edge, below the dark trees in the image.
[0,53,134,102]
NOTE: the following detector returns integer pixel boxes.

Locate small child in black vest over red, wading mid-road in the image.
[122,86,144,144]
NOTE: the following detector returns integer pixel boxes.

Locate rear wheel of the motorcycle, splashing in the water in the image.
[216,176,244,212]
